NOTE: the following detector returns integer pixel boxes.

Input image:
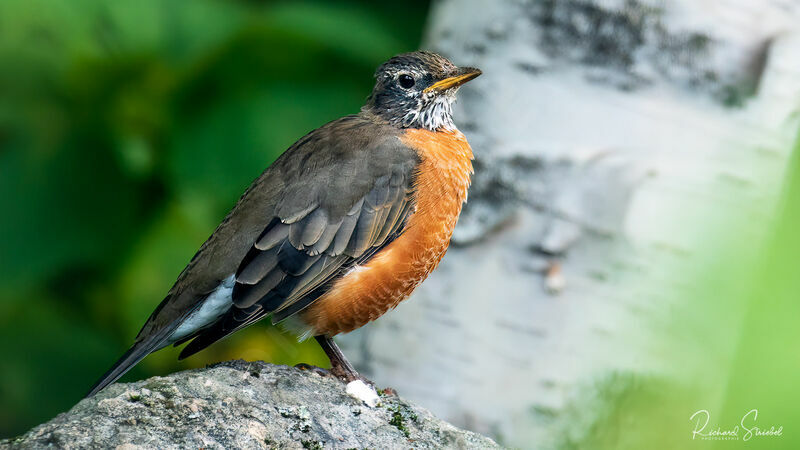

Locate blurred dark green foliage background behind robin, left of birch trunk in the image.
[0,0,428,436]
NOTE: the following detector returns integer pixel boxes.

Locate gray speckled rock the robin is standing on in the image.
[0,360,498,449]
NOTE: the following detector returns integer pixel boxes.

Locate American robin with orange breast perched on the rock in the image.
[88,52,481,396]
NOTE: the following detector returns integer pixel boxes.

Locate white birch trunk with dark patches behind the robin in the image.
[342,0,800,448]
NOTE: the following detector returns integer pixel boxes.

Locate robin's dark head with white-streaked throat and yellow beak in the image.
[363,52,481,131]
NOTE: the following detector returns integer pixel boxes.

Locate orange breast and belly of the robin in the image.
[302,130,472,336]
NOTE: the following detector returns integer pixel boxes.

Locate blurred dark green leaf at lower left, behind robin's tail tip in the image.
[0,295,118,436]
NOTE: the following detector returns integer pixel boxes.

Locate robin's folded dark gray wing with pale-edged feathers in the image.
[180,119,419,358]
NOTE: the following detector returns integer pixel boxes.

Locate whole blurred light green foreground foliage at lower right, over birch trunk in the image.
[552,128,800,450]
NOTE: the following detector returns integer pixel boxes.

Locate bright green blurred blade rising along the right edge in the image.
[715,130,800,449]
